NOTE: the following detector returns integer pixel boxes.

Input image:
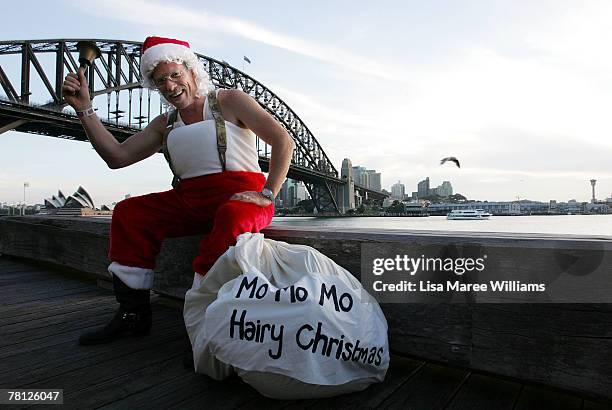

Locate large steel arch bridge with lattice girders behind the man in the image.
[0,39,386,214]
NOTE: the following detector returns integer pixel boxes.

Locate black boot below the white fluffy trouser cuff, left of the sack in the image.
[79,275,151,345]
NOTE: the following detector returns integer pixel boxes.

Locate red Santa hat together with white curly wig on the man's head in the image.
[140,37,215,105]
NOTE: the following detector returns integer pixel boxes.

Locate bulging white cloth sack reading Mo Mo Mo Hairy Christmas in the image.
[184,233,389,398]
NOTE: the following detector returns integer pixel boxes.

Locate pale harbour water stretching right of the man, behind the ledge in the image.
[272,215,612,239]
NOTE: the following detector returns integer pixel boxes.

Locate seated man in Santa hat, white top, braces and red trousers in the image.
[62,37,294,345]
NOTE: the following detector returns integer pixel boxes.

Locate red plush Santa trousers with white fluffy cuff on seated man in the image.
[108,171,274,288]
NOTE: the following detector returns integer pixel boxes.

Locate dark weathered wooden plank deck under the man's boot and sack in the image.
[0,257,610,410]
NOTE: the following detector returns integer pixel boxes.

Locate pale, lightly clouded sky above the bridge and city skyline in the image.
[0,0,612,206]
